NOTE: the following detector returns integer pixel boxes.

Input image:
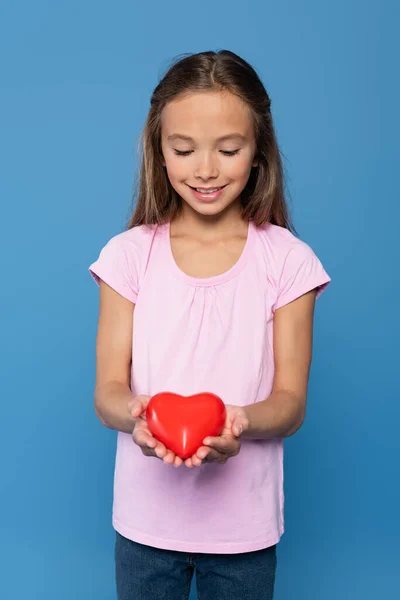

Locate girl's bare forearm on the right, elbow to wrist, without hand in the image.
[243,390,305,439]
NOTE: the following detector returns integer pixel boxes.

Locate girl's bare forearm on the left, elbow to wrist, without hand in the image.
[94,381,135,433]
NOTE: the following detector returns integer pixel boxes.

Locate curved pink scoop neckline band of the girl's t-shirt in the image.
[163,221,254,287]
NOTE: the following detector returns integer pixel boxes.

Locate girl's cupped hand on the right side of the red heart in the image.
[185,404,249,468]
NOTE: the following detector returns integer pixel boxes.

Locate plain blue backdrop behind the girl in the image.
[0,0,400,600]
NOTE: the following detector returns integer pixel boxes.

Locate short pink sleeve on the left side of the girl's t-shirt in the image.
[89,235,138,304]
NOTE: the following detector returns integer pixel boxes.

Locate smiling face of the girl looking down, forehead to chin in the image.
[161,91,257,216]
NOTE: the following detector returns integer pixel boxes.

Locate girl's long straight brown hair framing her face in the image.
[128,50,294,231]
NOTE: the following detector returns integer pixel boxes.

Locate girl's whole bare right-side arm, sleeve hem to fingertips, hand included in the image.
[189,290,316,466]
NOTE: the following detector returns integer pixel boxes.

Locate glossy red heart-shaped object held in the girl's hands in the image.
[146,392,226,460]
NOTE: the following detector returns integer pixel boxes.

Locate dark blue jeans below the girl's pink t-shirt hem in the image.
[115,532,276,600]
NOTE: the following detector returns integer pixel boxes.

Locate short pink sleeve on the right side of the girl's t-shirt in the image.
[275,242,331,310]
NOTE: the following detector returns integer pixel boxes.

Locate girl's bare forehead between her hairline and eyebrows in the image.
[161,91,253,138]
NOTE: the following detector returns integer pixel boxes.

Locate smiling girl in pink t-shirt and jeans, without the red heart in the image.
[90,51,330,600]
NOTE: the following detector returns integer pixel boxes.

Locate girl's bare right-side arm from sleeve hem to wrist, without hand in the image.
[243,290,316,439]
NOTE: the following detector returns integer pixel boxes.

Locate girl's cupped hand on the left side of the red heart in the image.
[128,396,183,467]
